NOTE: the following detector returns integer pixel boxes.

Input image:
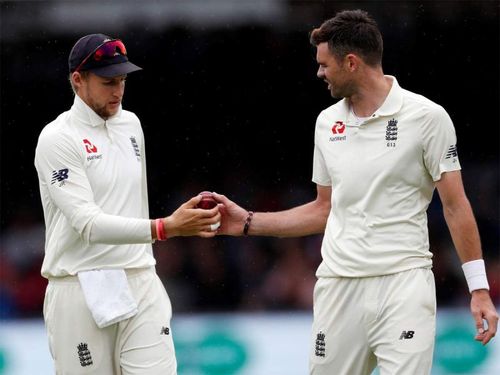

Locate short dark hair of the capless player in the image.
[310,9,383,66]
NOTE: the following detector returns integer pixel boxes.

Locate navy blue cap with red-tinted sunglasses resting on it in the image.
[68,34,142,78]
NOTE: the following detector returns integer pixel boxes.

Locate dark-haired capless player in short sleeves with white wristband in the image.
[215,10,498,375]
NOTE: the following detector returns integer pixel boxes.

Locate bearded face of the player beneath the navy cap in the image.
[78,73,127,119]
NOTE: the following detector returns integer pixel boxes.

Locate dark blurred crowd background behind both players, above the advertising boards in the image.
[0,0,500,319]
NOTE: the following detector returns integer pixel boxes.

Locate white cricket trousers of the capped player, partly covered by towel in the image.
[43,268,177,375]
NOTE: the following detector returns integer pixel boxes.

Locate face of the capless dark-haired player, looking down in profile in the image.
[316,42,354,99]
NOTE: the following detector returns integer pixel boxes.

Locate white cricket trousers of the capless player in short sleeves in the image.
[309,268,436,375]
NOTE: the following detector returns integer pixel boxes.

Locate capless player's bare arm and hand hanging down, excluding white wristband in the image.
[436,171,498,345]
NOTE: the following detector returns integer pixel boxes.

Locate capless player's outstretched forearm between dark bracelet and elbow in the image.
[248,201,330,237]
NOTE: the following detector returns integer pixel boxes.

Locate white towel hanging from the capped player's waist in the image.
[78,269,138,328]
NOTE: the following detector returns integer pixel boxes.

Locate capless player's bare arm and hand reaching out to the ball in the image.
[214,185,332,237]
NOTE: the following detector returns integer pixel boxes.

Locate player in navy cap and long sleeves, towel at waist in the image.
[35,34,220,374]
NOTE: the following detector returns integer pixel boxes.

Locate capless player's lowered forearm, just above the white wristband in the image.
[444,197,482,263]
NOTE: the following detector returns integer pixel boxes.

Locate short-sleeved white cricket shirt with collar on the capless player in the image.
[312,76,460,277]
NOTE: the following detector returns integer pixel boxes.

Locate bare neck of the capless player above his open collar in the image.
[349,68,392,117]
